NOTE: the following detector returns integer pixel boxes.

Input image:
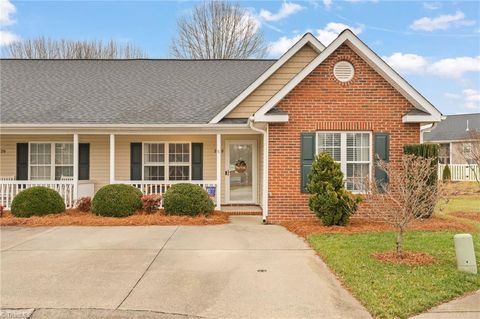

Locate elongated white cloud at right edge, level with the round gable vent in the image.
[428,56,480,79]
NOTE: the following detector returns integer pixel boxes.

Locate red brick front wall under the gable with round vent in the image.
[268,45,420,223]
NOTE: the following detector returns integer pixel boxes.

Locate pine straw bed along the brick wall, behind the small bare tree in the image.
[281,217,475,237]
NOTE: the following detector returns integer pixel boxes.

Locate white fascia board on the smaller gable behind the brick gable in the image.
[210,33,325,124]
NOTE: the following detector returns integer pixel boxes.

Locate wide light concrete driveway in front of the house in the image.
[0,216,370,319]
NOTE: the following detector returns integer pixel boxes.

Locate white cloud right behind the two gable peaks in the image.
[268,22,363,56]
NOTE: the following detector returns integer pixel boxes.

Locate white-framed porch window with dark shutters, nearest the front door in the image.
[143,143,190,181]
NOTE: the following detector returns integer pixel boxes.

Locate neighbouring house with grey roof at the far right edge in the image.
[423,113,480,180]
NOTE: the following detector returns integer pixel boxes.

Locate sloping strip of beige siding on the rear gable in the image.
[226,44,318,118]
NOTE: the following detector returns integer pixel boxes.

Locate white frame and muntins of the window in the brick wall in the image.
[315,131,373,194]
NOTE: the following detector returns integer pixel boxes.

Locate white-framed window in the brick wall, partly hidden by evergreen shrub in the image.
[317,132,372,192]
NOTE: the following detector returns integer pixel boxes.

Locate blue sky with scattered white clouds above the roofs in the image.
[0,0,480,114]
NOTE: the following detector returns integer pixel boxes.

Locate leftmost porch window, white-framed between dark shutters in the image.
[30,143,73,180]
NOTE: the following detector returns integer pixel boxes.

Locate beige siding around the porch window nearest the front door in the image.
[115,135,217,181]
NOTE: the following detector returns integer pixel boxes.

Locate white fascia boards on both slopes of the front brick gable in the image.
[257,29,442,122]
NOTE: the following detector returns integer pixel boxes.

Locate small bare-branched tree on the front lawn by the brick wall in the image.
[364,155,439,257]
